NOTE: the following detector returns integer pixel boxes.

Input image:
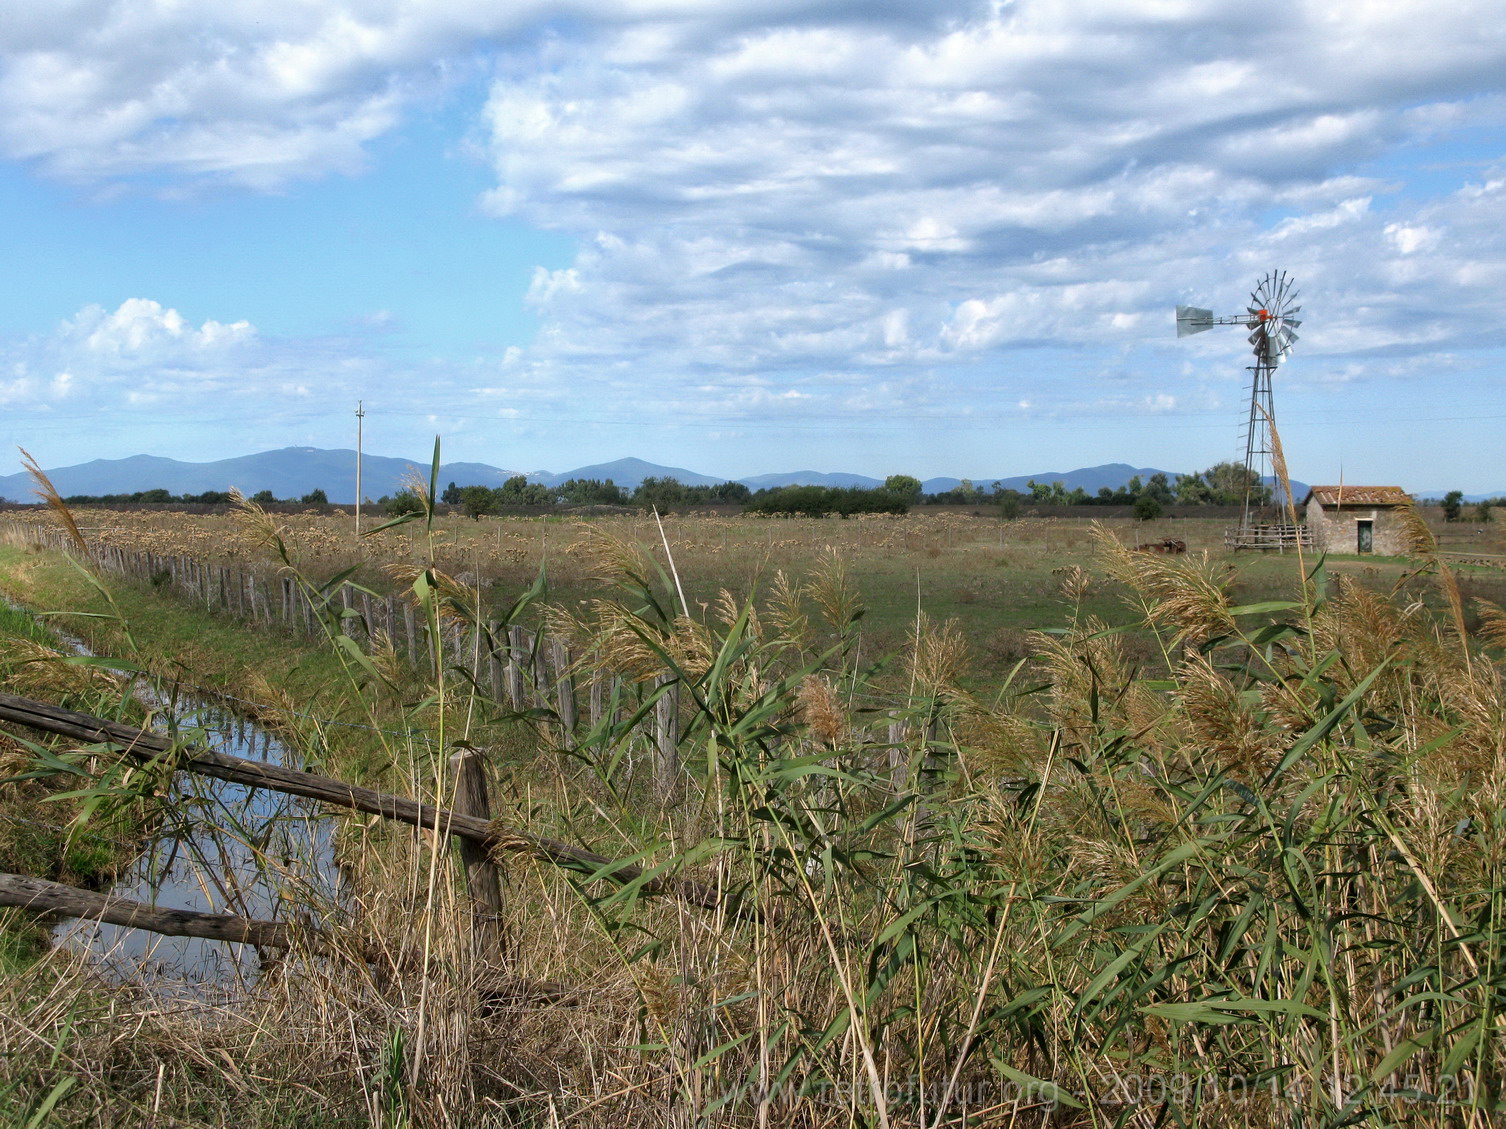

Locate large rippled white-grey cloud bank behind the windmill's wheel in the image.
[454,2,1506,424]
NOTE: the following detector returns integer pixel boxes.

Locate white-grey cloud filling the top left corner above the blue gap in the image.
[0,0,968,190]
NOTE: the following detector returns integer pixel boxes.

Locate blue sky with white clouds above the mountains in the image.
[0,0,1506,492]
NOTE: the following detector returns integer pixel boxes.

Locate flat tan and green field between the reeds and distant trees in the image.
[5,507,1506,685]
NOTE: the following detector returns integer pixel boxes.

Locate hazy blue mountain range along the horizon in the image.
[0,447,1307,504]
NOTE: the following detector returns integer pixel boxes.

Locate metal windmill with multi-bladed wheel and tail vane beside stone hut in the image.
[1176,271,1303,530]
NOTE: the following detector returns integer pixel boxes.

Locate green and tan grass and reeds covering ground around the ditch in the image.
[0,509,1506,1129]
